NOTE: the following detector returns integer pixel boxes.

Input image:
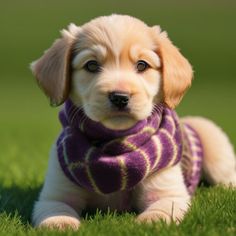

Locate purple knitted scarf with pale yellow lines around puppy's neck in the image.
[57,100,203,194]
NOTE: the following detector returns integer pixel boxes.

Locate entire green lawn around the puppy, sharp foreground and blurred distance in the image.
[0,0,236,236]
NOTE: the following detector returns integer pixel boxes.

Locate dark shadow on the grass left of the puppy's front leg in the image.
[0,184,41,224]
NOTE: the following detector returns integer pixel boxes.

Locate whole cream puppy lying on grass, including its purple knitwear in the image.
[31,15,236,229]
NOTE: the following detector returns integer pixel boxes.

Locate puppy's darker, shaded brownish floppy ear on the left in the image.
[31,24,80,106]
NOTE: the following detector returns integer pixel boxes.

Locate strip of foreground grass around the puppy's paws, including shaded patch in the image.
[0,186,236,236]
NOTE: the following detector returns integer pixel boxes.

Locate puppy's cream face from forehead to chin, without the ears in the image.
[71,17,161,128]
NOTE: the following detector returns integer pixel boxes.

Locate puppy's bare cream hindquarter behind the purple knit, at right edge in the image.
[182,117,236,187]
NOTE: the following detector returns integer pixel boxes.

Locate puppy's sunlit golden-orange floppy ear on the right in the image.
[153,26,193,108]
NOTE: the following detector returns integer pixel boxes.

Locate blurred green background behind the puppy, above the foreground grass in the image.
[0,0,236,185]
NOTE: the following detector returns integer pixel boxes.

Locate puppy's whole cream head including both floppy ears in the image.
[32,15,192,129]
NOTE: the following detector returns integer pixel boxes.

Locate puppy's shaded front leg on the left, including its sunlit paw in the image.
[32,143,85,230]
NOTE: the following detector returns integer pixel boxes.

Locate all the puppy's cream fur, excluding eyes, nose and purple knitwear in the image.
[32,15,236,230]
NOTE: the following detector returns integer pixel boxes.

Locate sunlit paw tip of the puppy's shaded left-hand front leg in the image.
[37,216,80,231]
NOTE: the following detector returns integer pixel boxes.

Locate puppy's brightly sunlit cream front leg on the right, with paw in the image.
[137,164,190,223]
